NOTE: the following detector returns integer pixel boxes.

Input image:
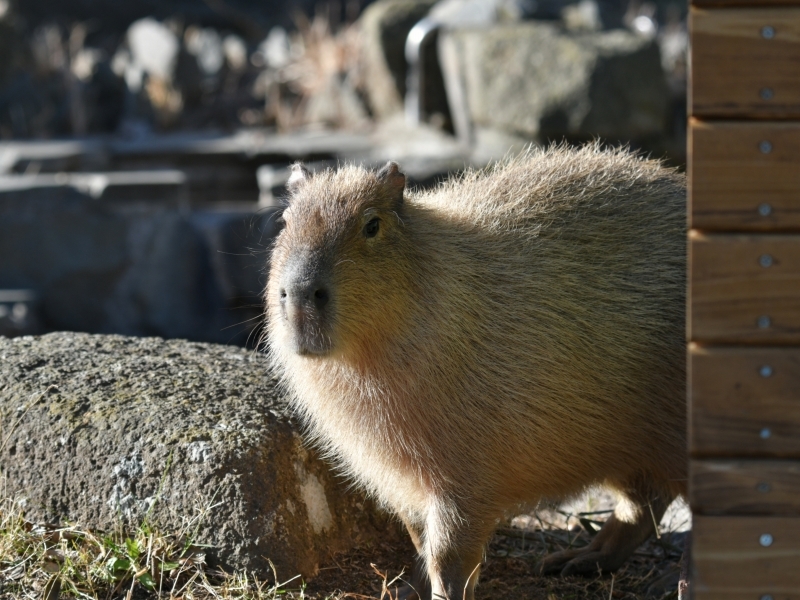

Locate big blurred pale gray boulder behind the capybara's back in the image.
[439,22,669,140]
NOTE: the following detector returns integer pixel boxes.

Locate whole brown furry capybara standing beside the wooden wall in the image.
[266,143,687,600]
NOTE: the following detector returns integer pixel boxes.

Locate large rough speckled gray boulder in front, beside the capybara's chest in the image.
[0,333,396,578]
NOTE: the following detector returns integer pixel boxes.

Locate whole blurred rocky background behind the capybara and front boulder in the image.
[0,0,687,346]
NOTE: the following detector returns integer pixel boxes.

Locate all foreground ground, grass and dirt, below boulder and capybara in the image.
[0,492,683,600]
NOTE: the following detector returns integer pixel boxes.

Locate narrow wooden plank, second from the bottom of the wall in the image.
[689,460,800,517]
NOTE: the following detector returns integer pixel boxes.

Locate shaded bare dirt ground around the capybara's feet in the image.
[306,492,690,600]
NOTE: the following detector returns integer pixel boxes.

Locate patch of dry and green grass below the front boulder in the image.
[0,499,306,600]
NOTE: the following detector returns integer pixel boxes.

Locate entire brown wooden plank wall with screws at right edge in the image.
[688,0,800,600]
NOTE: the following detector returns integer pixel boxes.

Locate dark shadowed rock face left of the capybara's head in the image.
[0,187,277,344]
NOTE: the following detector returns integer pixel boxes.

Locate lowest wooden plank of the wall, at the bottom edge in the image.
[692,516,800,600]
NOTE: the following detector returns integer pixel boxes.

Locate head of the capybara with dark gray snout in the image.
[266,163,418,359]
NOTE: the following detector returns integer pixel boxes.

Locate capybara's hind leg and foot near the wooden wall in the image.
[539,482,673,575]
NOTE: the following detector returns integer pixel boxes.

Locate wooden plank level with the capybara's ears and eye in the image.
[689,119,800,231]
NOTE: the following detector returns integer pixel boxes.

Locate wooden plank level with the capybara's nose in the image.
[689,230,800,344]
